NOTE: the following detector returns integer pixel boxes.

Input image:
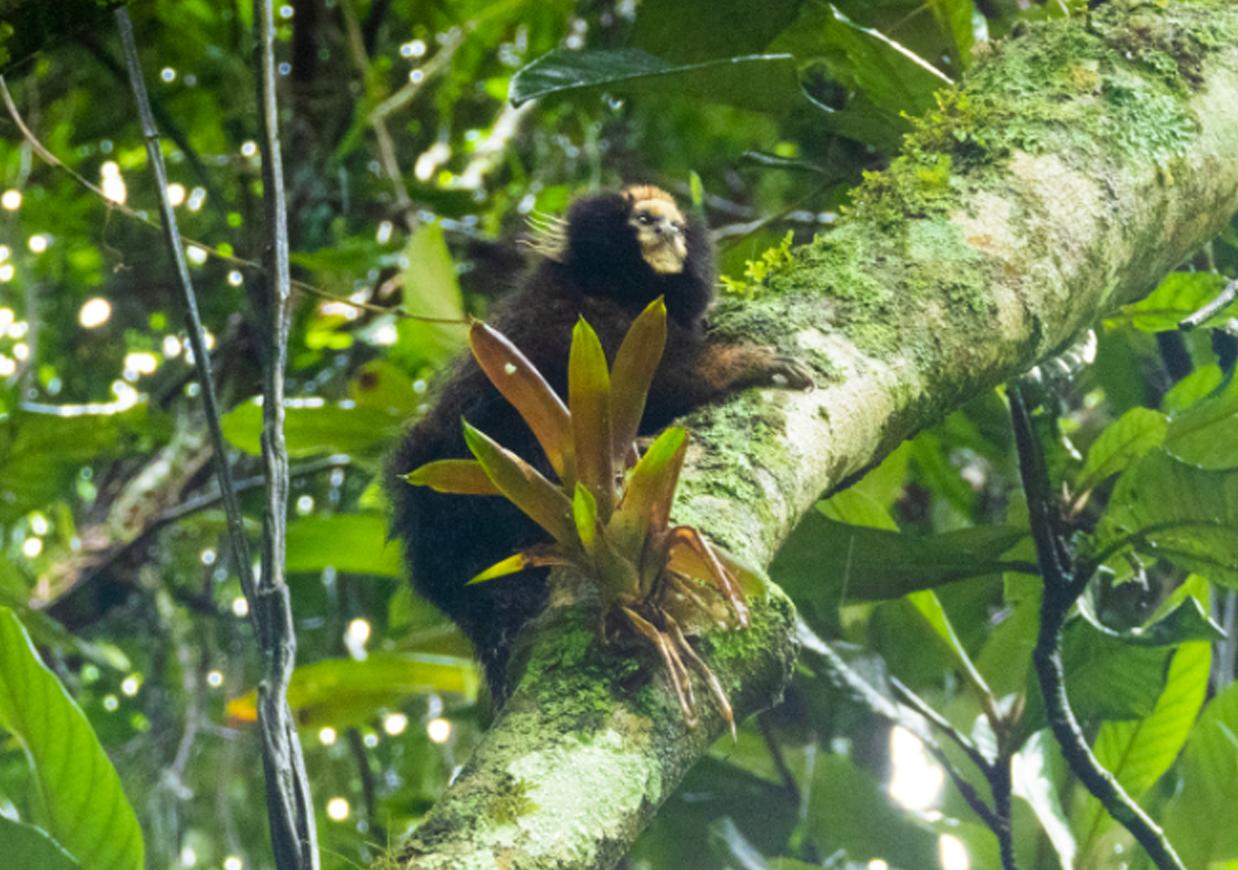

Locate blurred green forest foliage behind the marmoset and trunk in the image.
[0,0,1238,870]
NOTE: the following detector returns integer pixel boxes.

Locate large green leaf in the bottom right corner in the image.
[1164,683,1238,868]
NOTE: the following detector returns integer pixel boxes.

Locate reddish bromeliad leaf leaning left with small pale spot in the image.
[469,321,576,488]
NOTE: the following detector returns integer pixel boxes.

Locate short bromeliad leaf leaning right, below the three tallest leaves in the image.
[612,427,688,553]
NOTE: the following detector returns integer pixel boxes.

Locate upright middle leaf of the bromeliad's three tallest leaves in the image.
[567,319,615,525]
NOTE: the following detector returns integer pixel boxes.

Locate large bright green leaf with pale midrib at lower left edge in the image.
[0,608,142,870]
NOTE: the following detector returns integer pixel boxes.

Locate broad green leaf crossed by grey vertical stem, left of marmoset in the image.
[220,401,404,459]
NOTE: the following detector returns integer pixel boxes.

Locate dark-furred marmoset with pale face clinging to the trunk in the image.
[387,186,812,703]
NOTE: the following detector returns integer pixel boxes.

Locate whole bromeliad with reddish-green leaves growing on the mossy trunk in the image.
[406,298,749,734]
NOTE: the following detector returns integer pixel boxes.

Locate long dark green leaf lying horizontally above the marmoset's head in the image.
[509,48,800,113]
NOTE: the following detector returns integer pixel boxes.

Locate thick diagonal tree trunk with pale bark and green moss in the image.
[401,2,1238,868]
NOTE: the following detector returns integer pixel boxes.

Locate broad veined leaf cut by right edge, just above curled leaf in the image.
[1096,450,1238,587]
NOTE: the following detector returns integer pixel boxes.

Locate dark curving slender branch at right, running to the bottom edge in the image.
[1006,386,1185,870]
